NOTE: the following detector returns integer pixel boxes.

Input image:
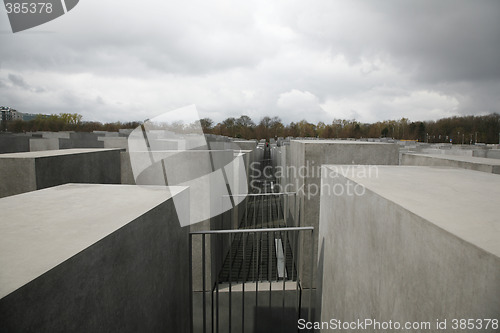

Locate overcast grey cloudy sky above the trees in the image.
[0,0,500,123]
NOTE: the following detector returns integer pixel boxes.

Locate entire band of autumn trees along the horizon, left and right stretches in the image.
[7,113,500,144]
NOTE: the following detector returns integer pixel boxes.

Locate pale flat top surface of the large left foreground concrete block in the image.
[0,184,186,298]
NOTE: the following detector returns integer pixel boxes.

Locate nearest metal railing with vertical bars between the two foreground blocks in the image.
[189,227,314,333]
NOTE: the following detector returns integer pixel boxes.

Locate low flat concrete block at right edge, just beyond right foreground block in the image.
[401,154,500,174]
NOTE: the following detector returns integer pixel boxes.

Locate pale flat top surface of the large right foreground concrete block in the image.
[326,165,500,258]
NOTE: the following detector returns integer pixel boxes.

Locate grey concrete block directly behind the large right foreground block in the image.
[286,140,399,286]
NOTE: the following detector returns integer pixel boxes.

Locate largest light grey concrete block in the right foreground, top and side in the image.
[318,166,500,332]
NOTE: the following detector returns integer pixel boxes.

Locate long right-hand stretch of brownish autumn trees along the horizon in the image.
[201,113,500,144]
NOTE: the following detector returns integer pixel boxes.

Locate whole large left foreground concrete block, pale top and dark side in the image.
[0,184,189,332]
